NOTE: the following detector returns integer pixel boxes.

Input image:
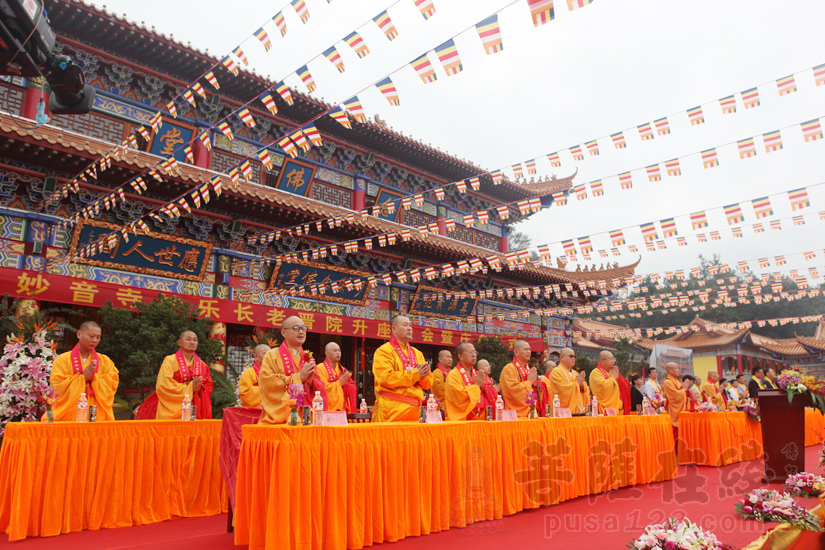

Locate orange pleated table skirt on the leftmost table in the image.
[0,420,227,541]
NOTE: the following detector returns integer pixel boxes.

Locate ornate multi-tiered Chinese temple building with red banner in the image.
[0,0,638,402]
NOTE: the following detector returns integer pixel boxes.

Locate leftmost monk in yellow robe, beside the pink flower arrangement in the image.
[51,321,119,422]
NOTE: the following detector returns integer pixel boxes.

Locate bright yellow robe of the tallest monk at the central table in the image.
[372,337,433,422]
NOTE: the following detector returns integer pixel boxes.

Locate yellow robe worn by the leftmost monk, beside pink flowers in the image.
[51,347,120,422]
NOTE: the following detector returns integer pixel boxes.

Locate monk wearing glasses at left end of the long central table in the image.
[258,316,329,424]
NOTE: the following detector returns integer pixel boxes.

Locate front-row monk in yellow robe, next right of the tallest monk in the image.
[447,342,497,421]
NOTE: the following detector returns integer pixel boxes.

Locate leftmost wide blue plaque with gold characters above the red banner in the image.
[69,220,212,281]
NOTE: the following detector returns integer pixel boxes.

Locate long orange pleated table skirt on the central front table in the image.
[235,416,676,550]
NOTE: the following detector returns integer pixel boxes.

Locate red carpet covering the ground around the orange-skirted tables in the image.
[6,446,825,550]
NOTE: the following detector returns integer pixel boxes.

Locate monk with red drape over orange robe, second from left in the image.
[137,330,213,420]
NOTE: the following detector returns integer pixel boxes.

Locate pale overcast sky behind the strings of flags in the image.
[91,0,825,282]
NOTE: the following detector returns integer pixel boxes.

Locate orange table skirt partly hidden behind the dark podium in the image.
[679,409,825,466]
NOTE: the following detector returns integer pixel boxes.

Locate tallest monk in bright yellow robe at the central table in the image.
[372,315,433,422]
